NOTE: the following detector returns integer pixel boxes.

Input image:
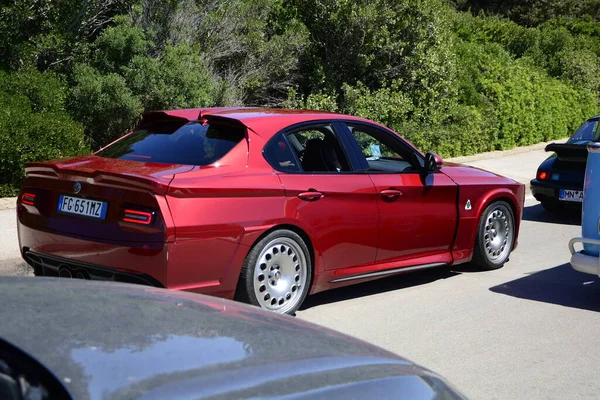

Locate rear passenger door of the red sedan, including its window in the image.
[265,122,379,270]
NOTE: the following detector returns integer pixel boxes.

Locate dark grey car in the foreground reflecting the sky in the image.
[0,278,464,400]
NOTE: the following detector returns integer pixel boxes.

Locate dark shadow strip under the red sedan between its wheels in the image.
[300,267,460,310]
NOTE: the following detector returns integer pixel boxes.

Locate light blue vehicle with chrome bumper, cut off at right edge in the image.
[569,143,600,276]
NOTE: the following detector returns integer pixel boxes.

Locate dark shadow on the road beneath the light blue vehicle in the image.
[490,263,600,311]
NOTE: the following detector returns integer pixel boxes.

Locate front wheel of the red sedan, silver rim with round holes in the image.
[472,201,516,270]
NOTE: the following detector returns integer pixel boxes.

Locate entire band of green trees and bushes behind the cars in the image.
[0,0,600,195]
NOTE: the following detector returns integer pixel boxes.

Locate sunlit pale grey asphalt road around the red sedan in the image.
[0,145,600,399]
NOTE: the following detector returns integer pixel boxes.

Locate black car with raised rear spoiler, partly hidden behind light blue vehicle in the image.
[531,115,600,211]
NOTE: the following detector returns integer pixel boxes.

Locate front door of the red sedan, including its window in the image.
[338,122,458,263]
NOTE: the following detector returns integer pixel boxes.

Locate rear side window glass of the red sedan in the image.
[264,124,351,172]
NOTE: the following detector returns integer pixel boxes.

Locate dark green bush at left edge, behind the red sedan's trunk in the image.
[0,70,89,196]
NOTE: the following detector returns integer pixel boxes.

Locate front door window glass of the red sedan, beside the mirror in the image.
[347,123,422,173]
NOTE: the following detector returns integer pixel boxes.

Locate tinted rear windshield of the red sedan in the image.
[96,120,245,165]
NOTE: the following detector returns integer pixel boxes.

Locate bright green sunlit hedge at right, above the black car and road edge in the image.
[458,43,598,149]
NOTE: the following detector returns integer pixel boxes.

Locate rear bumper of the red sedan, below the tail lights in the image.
[17,217,249,299]
